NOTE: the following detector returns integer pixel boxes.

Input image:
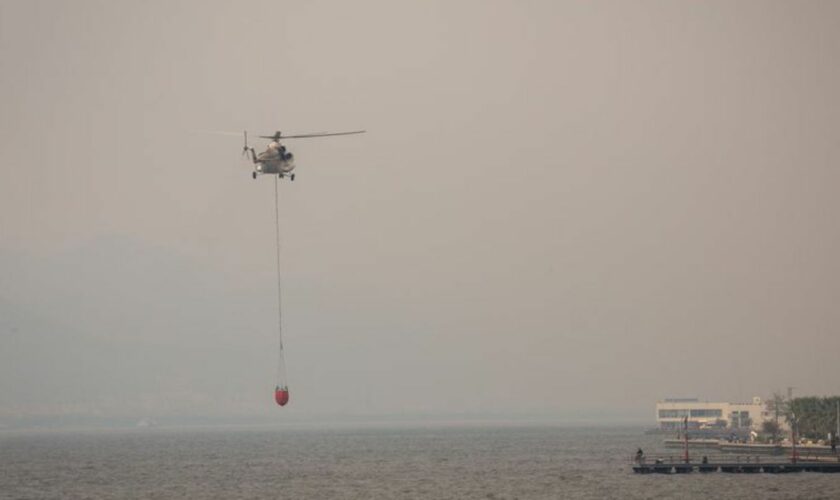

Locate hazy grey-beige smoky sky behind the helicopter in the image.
[0,0,840,422]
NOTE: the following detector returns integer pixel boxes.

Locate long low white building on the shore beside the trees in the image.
[656,396,770,430]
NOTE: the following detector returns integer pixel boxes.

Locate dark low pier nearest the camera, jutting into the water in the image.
[633,455,840,474]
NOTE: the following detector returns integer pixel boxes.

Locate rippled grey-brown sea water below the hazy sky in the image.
[0,424,840,499]
